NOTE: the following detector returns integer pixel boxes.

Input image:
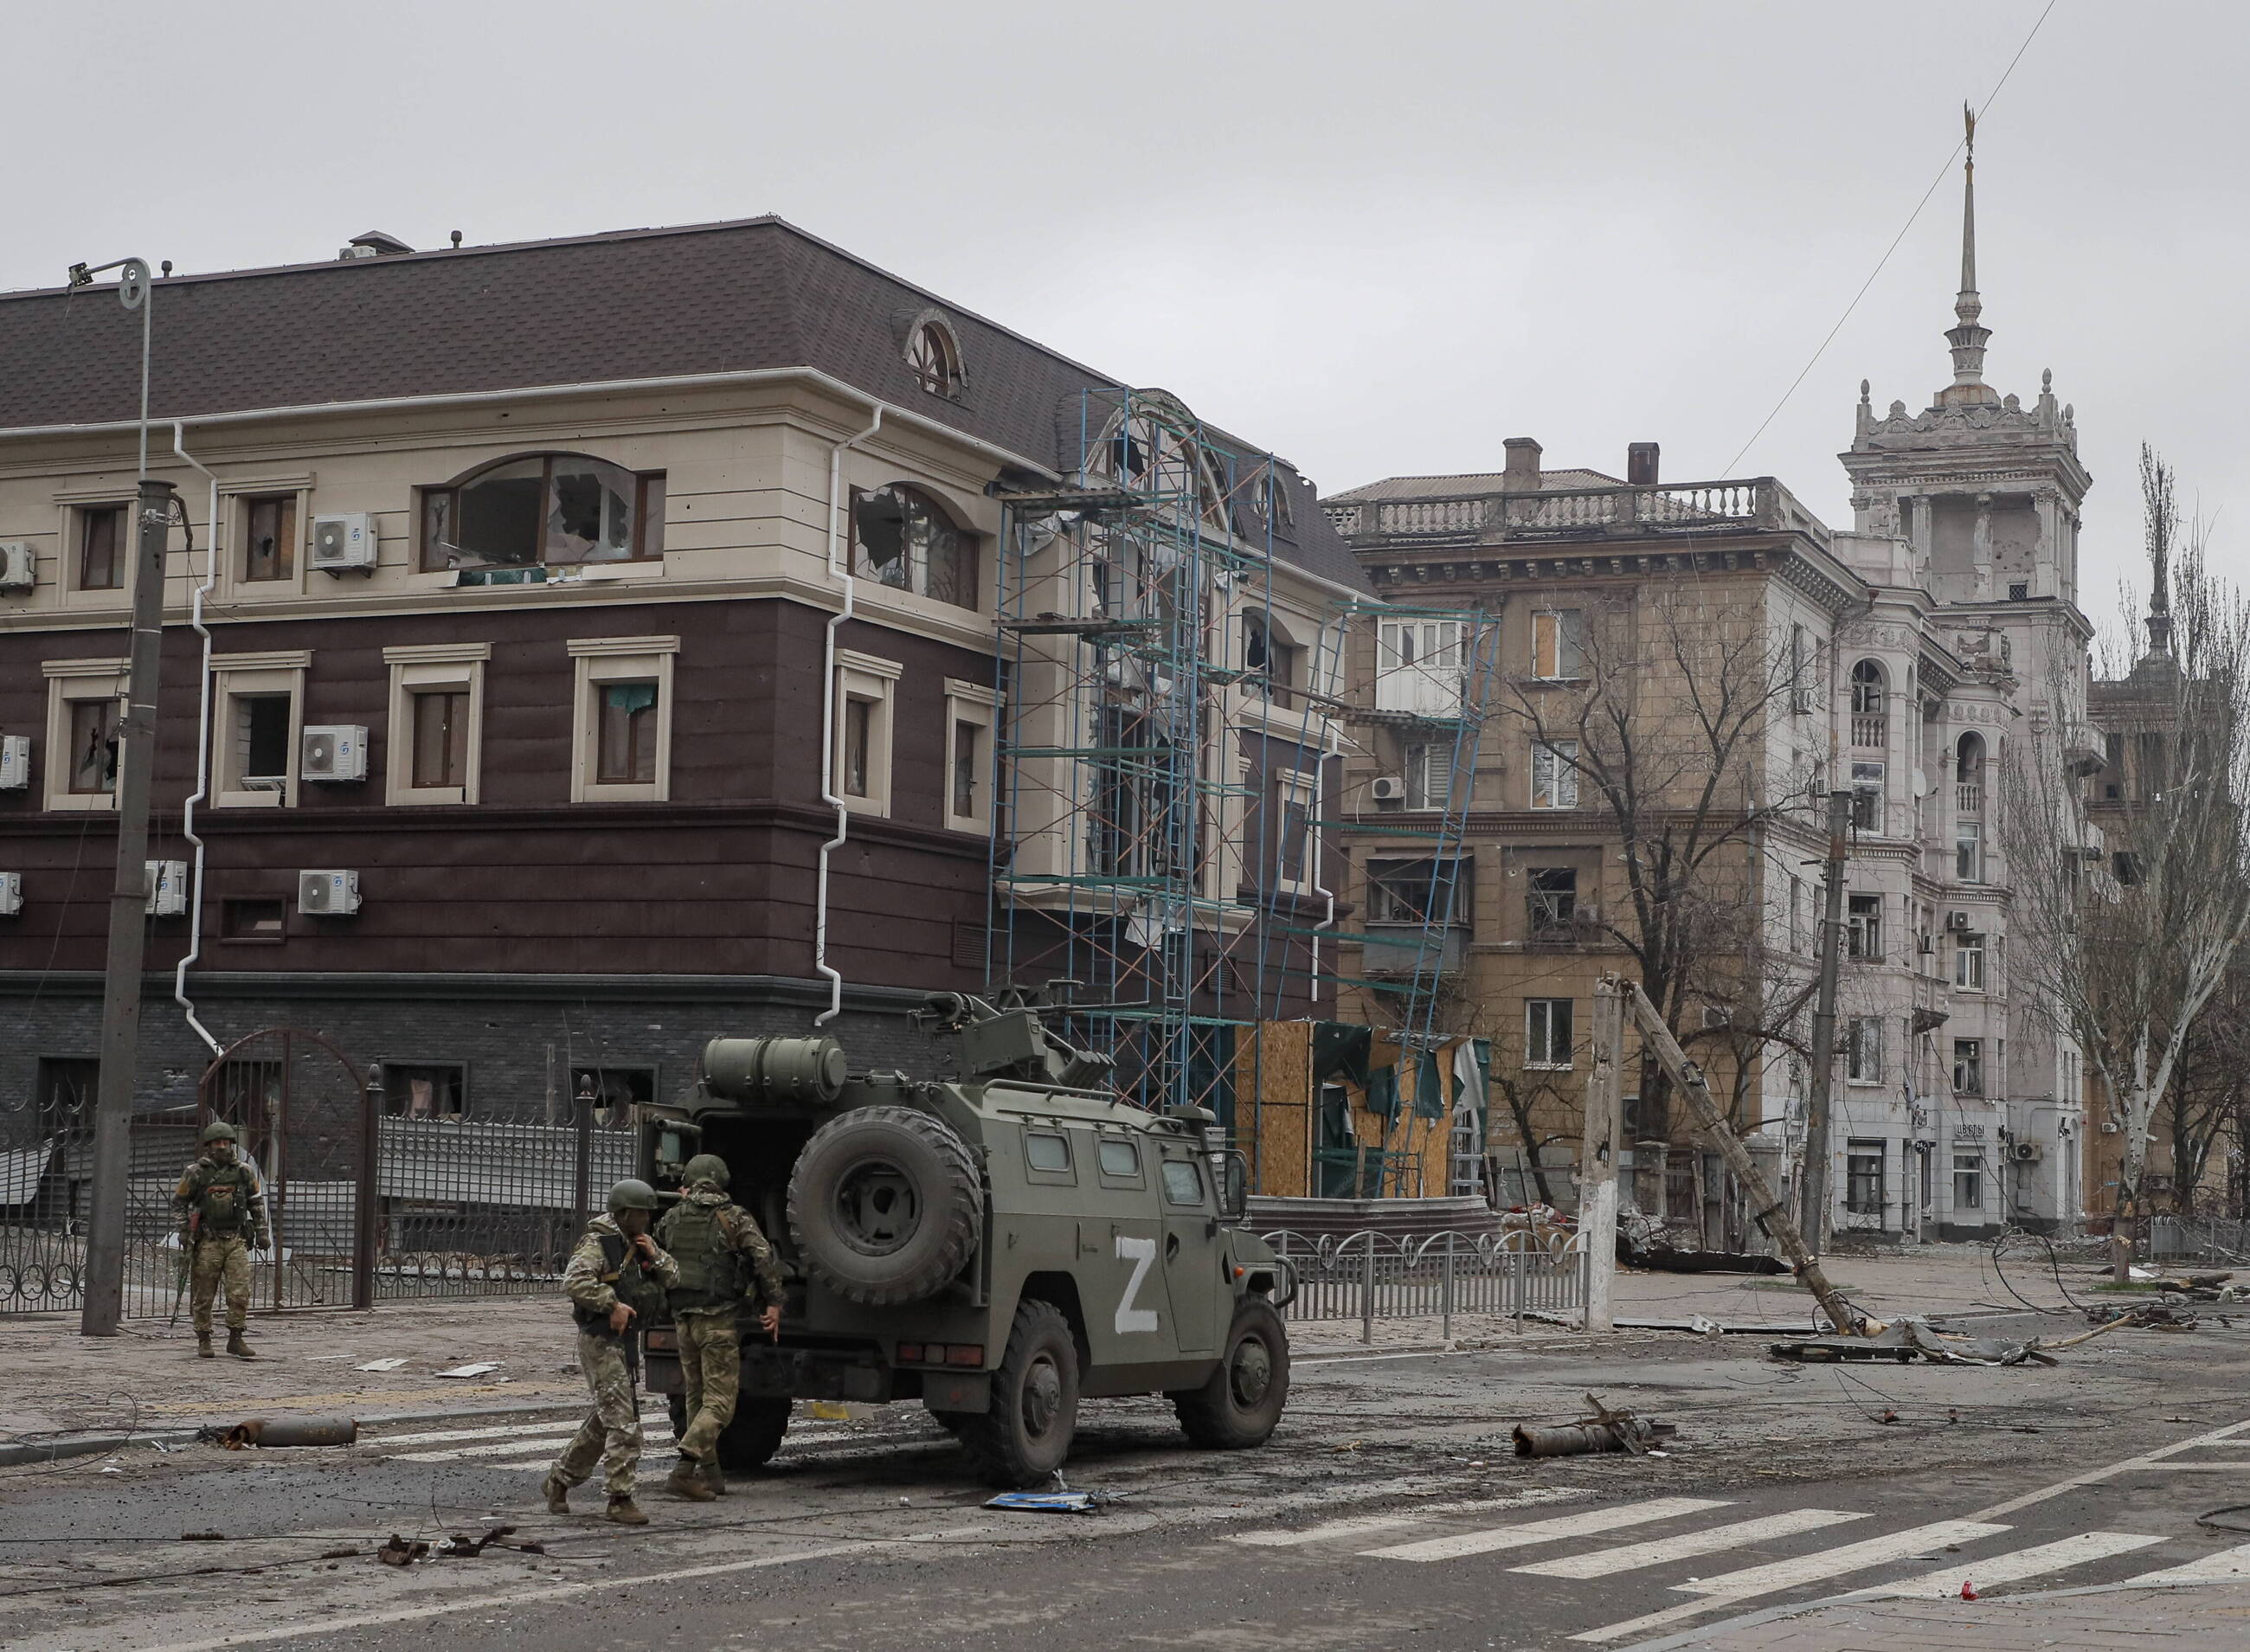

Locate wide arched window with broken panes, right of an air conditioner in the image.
[421,453,664,572]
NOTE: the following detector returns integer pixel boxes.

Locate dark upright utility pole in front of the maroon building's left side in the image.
[79,475,173,1337]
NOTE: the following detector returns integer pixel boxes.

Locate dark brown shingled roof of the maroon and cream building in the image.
[0,218,1368,592]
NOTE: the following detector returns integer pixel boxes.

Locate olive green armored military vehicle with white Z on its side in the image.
[644,993,1294,1486]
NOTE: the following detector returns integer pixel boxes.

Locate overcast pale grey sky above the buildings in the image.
[0,0,2250,619]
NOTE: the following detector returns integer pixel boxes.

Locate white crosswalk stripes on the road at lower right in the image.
[1231,1497,2250,1645]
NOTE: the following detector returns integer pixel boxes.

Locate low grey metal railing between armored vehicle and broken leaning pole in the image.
[1264,1229,1586,1341]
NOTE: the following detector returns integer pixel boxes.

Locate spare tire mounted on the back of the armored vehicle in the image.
[790,1108,983,1308]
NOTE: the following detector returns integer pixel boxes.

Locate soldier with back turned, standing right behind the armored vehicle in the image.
[657,1153,783,1503]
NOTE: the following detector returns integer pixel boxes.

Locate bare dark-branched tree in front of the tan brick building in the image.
[1494,578,1811,1139]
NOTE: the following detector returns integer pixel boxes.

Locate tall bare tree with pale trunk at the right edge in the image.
[1998,448,2250,1278]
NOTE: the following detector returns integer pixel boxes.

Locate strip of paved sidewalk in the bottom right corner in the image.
[1658,1582,2250,1652]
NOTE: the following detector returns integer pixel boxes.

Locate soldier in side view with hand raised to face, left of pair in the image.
[540,1177,679,1526]
